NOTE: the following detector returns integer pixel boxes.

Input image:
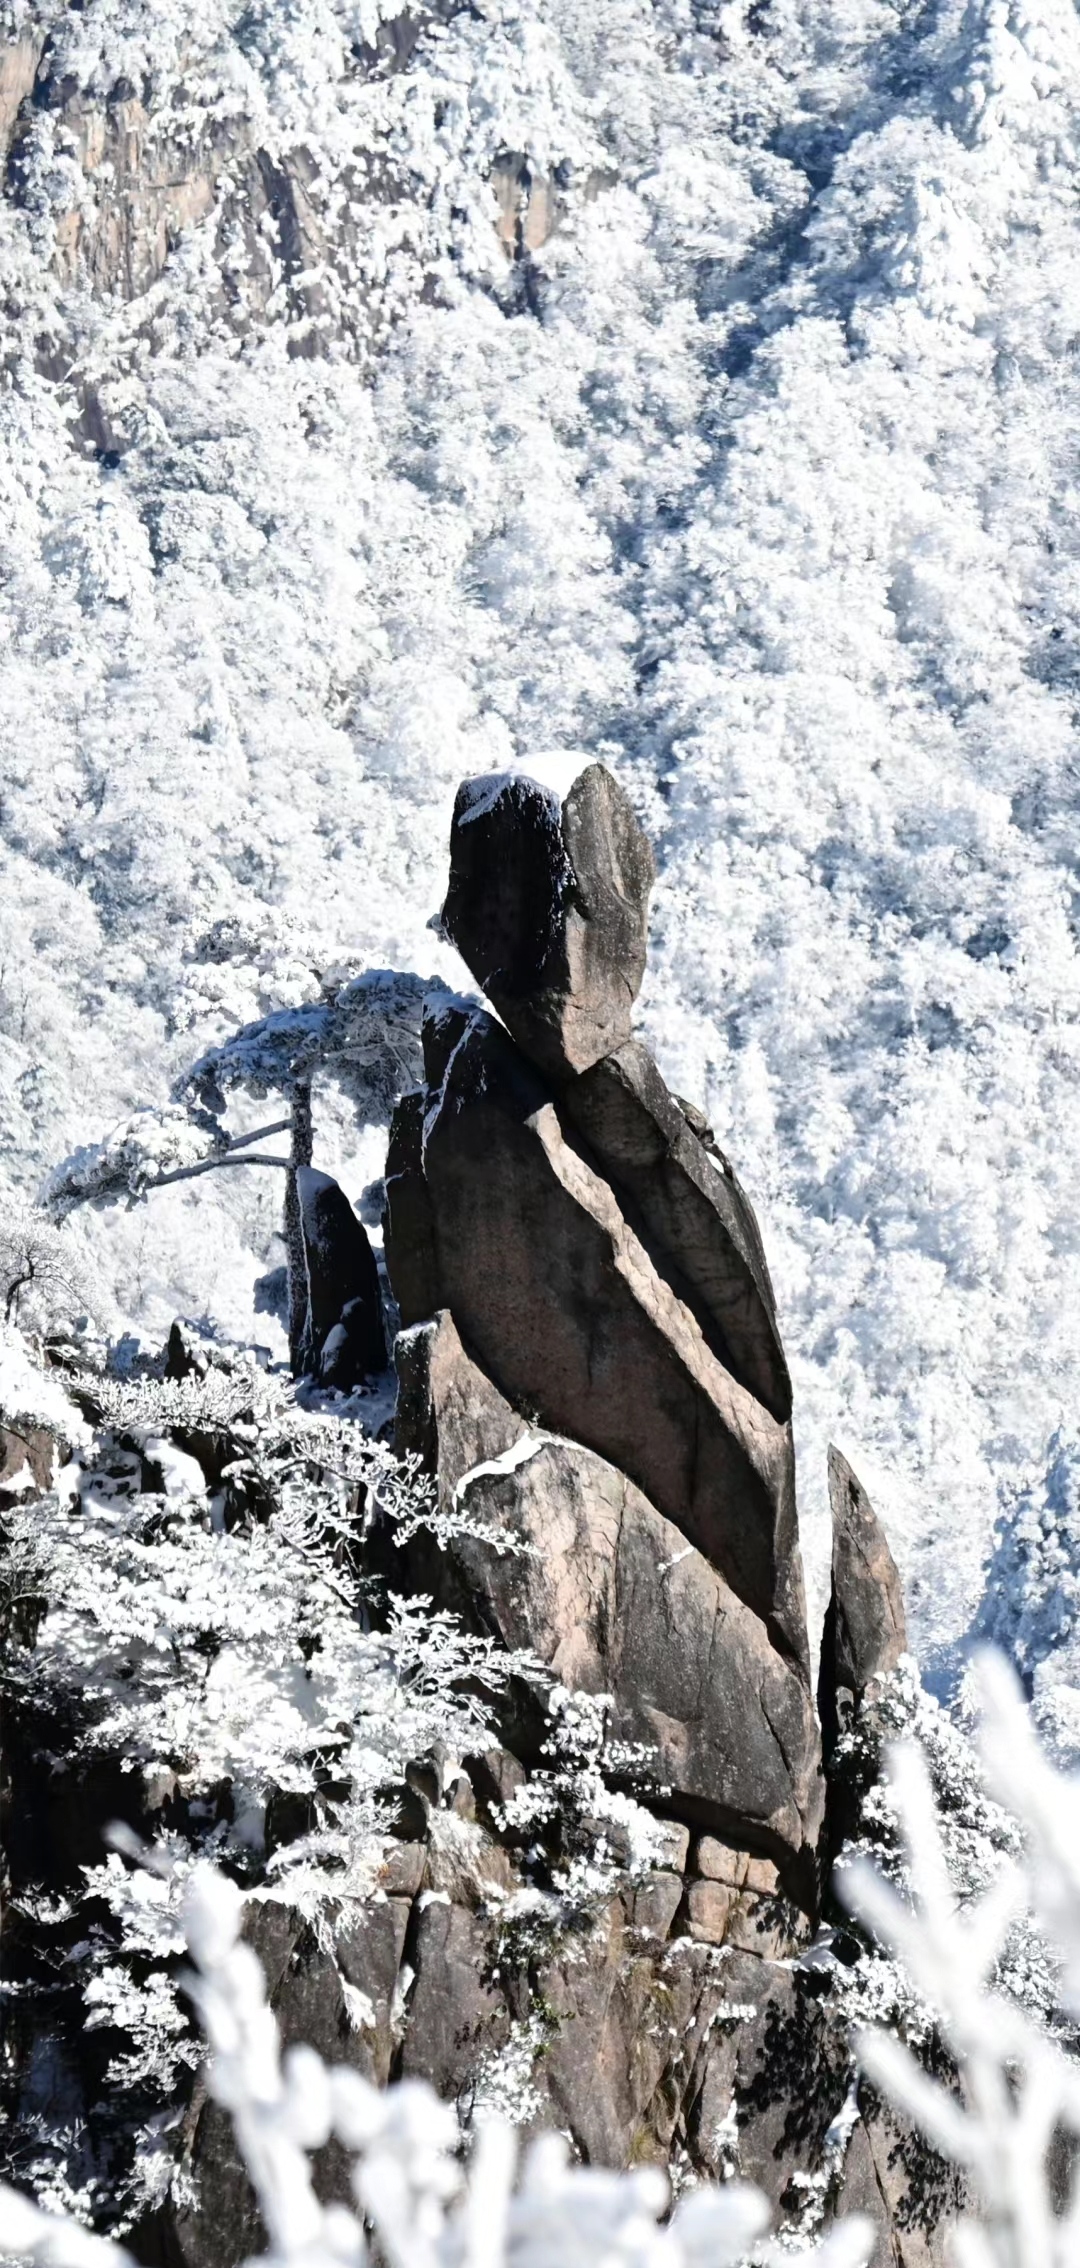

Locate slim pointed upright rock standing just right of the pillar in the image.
[817,1449,908,1751]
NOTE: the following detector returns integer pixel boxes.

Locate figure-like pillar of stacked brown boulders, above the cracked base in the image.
[386,764,821,1910]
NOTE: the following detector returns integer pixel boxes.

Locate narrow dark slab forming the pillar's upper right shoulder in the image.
[560,1039,792,1424]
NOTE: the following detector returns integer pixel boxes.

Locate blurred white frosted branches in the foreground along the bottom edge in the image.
[0,1660,1080,2268]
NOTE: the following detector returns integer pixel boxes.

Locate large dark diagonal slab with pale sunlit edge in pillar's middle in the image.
[410,1007,810,1683]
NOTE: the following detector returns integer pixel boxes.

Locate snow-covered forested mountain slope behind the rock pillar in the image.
[0,0,1080,1665]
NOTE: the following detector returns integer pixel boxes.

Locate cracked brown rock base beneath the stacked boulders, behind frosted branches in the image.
[159,1812,962,2268]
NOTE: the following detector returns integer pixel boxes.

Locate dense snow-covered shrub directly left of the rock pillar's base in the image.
[7,1359,544,1880]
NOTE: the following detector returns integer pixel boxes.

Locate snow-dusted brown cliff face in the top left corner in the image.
[0,0,560,358]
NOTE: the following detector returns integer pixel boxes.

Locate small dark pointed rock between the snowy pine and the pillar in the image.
[297,1166,386,1393]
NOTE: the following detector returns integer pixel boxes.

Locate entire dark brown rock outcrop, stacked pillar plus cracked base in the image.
[0,767,930,2268]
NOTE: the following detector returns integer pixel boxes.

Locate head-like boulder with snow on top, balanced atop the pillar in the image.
[442,764,656,1080]
